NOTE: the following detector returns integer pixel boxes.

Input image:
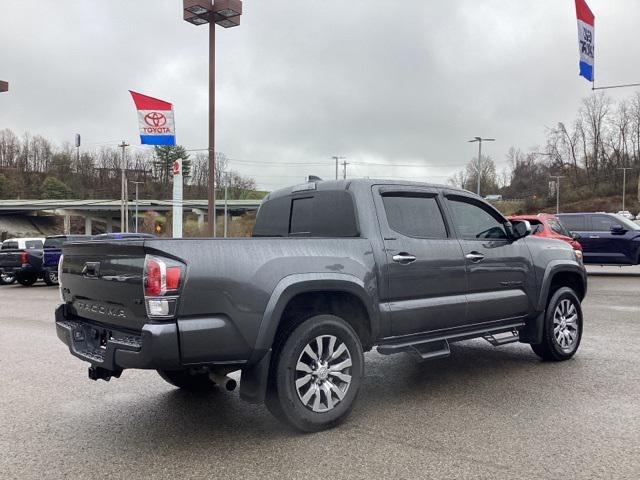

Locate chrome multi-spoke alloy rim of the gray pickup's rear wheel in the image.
[295,335,352,413]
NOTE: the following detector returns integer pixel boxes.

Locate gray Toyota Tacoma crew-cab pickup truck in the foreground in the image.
[56,180,587,431]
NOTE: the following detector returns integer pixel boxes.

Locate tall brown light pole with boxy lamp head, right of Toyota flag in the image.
[182,0,242,237]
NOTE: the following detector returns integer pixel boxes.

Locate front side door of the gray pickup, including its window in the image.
[446,192,536,324]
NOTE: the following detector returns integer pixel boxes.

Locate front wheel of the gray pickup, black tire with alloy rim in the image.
[531,287,583,362]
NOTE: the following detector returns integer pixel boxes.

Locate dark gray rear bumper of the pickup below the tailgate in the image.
[56,305,181,371]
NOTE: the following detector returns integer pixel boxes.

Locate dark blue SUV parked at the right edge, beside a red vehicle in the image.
[558,213,640,265]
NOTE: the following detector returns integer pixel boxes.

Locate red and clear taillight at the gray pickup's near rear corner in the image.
[144,255,184,318]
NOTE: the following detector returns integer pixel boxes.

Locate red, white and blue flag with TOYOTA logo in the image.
[129,90,176,145]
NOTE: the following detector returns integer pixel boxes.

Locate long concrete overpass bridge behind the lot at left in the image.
[0,200,260,234]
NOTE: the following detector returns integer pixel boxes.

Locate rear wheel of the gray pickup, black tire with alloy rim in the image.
[265,315,364,432]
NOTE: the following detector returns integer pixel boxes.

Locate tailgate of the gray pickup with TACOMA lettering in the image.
[60,240,148,331]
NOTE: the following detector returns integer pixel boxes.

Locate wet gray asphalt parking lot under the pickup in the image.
[0,267,640,480]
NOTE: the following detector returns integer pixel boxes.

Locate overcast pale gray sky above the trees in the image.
[0,0,640,189]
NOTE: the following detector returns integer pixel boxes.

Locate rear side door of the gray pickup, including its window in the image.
[374,186,467,336]
